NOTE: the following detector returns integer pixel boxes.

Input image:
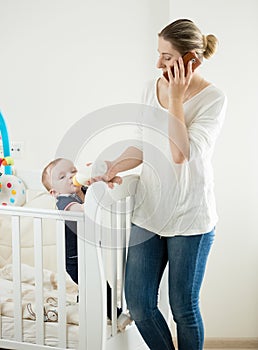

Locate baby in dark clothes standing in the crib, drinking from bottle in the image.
[42,158,131,331]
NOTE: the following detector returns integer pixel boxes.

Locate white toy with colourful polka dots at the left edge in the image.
[0,174,26,206]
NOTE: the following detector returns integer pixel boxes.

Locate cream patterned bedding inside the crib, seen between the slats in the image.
[0,264,114,349]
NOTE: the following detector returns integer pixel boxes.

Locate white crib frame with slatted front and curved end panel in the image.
[0,175,138,350]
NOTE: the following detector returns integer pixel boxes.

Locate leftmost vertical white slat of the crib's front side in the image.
[12,216,22,342]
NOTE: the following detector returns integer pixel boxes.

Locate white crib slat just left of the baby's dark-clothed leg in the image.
[56,220,66,349]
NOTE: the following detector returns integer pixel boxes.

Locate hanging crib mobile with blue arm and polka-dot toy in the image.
[0,112,26,206]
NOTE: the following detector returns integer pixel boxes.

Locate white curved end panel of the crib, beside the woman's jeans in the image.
[84,175,138,349]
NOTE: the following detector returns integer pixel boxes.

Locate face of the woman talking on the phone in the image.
[157,37,181,73]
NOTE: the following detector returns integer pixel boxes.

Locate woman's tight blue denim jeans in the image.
[125,225,214,350]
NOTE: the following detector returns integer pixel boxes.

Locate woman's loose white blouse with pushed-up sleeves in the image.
[132,81,227,236]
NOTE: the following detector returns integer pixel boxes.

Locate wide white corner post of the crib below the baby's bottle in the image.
[84,189,107,350]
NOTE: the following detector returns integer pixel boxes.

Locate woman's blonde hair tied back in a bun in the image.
[158,19,218,59]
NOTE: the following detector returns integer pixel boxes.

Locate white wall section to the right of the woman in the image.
[170,0,258,338]
